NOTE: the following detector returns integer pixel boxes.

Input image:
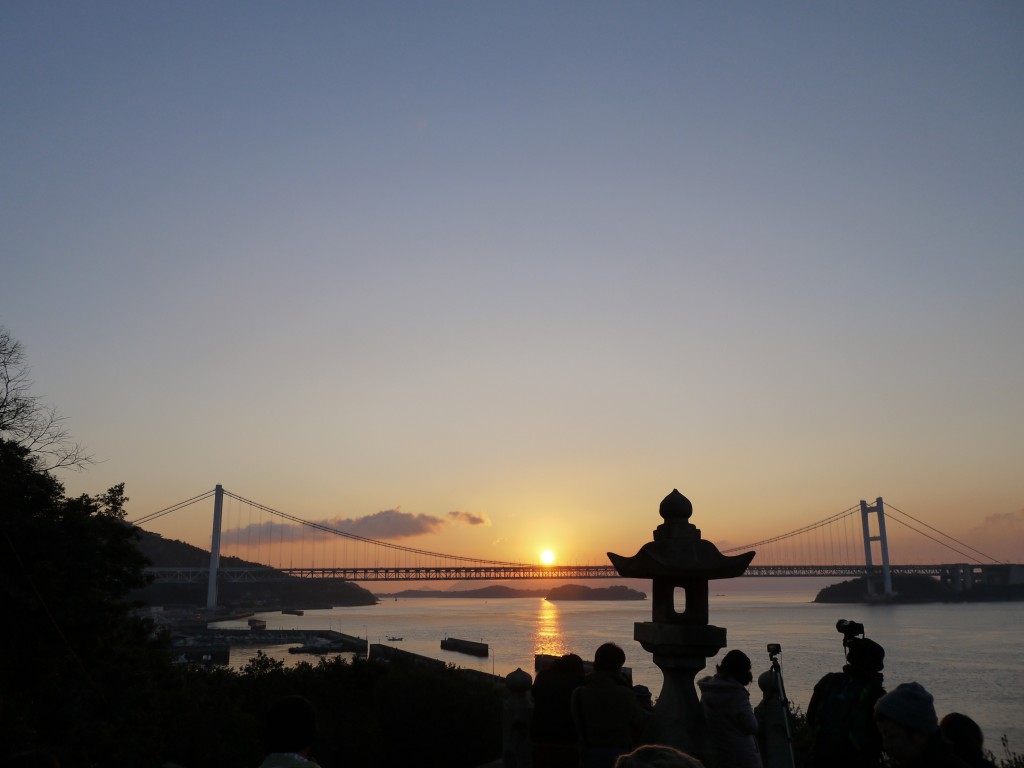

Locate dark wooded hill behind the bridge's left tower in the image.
[132,530,377,610]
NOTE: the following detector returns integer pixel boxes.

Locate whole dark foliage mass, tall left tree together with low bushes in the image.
[0,434,505,768]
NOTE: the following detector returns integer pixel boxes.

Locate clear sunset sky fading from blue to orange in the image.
[0,0,1024,563]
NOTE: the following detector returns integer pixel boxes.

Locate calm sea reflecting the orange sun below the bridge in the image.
[209,578,1024,755]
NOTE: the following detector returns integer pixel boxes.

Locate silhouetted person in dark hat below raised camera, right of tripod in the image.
[807,637,886,768]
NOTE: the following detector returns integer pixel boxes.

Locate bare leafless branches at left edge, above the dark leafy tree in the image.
[0,327,92,471]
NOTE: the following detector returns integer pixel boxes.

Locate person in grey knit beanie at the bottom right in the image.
[874,683,968,768]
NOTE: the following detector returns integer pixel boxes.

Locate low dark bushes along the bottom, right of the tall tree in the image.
[149,653,504,768]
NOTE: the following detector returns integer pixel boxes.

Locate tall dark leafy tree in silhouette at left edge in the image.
[0,439,178,765]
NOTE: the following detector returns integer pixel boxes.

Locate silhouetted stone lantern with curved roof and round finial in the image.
[608,490,756,756]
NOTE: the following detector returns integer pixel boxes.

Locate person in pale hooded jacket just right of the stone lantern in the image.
[697,649,763,768]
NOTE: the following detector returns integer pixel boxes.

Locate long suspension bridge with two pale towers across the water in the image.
[131,485,1008,607]
